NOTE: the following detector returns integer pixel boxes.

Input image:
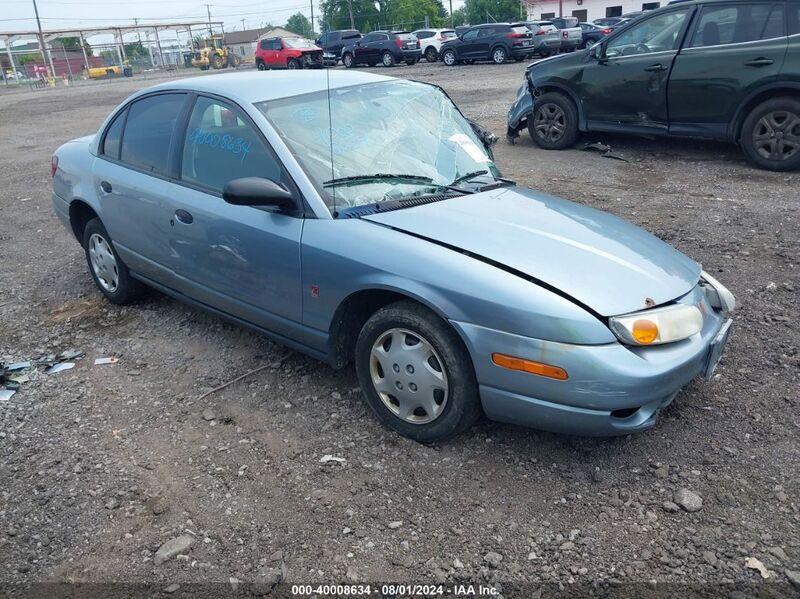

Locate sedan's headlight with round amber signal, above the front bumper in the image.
[609,304,703,345]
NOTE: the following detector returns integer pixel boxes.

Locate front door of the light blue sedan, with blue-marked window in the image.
[170,96,303,336]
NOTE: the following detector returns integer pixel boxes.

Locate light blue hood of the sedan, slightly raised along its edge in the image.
[364,188,701,316]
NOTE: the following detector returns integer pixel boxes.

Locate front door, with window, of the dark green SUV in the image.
[579,8,693,132]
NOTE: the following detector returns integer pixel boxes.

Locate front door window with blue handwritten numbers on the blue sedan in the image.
[181,96,281,193]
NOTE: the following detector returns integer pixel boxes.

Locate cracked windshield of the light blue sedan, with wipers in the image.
[258,81,500,211]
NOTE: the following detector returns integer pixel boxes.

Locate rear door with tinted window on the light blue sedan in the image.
[93,93,189,285]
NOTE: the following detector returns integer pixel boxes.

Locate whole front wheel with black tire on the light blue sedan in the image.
[355,301,481,443]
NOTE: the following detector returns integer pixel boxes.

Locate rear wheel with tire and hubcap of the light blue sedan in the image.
[83,218,145,305]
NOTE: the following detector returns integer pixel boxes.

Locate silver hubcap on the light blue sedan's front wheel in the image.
[369,328,449,424]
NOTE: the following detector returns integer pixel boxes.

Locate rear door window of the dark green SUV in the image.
[691,4,786,48]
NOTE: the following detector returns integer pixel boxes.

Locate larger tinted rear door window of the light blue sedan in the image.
[120,94,186,174]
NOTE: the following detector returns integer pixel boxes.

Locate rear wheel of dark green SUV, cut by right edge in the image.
[740,96,800,171]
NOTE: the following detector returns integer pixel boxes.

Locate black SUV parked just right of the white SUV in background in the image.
[441,23,535,67]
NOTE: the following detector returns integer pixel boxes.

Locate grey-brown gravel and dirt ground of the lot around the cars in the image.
[0,63,800,597]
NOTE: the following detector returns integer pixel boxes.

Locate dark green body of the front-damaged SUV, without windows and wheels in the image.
[508,0,800,143]
